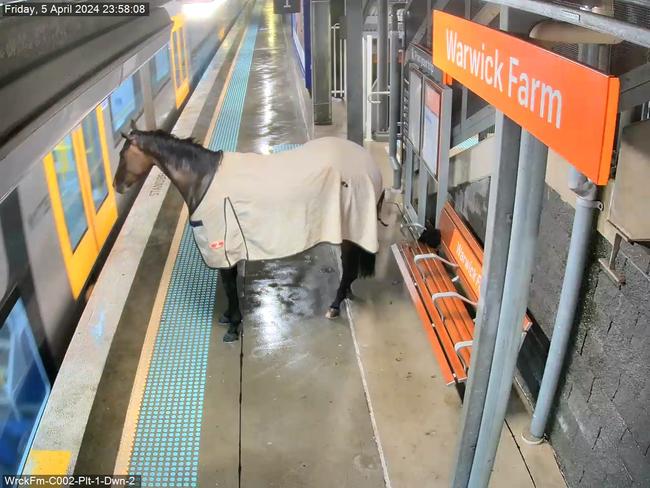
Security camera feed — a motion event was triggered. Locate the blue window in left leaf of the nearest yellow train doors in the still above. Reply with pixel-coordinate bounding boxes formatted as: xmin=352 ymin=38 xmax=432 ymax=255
xmin=52 ymin=135 xmax=88 ymax=250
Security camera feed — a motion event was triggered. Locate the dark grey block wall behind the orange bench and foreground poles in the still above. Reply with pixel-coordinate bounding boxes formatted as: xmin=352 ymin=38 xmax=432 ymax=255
xmin=452 ymin=178 xmax=650 ymax=488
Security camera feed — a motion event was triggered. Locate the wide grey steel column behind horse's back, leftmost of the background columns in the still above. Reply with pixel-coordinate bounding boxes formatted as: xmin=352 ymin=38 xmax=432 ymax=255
xmin=310 ymin=0 xmax=332 ymax=125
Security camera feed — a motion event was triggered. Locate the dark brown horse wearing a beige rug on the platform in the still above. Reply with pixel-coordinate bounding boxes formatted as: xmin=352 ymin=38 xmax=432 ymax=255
xmin=113 ymin=122 xmax=384 ymax=342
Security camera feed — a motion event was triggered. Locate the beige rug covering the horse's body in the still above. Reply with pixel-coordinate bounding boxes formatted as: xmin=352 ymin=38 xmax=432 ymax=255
xmin=190 ymin=137 xmax=382 ymax=268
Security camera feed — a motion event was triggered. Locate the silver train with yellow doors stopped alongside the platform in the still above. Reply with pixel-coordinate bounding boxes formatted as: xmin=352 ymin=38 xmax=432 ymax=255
xmin=0 ymin=0 xmax=250 ymax=473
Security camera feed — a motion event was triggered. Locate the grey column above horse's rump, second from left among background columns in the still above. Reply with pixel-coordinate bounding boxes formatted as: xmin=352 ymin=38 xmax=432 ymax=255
xmin=345 ymin=0 xmax=364 ymax=144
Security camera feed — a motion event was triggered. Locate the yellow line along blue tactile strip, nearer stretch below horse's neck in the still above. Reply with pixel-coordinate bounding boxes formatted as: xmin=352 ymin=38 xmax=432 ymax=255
xmin=114 ymin=205 xmax=187 ymax=475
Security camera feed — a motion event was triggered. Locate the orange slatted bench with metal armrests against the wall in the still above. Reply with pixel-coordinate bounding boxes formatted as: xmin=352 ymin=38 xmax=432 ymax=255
xmin=392 ymin=203 xmax=532 ymax=385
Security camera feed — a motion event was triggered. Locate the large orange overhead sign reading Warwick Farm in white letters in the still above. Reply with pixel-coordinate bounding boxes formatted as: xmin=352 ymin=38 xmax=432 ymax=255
xmin=433 ymin=10 xmax=620 ymax=185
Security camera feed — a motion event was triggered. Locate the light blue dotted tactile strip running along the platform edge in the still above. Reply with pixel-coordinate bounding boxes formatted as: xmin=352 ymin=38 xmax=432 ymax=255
xmin=129 ymin=6 xmax=260 ymax=488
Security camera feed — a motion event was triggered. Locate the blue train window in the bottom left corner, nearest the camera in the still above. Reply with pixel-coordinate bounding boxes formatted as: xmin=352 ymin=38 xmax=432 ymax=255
xmin=0 ymin=296 xmax=50 ymax=473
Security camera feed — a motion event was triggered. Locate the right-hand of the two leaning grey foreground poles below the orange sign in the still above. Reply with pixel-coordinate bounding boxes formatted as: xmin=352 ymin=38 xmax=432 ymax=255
xmin=468 ymin=130 xmax=548 ymax=488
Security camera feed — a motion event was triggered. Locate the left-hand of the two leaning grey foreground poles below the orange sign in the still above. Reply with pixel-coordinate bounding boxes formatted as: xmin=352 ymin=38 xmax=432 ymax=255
xmin=451 ymin=112 xmax=521 ymax=488
